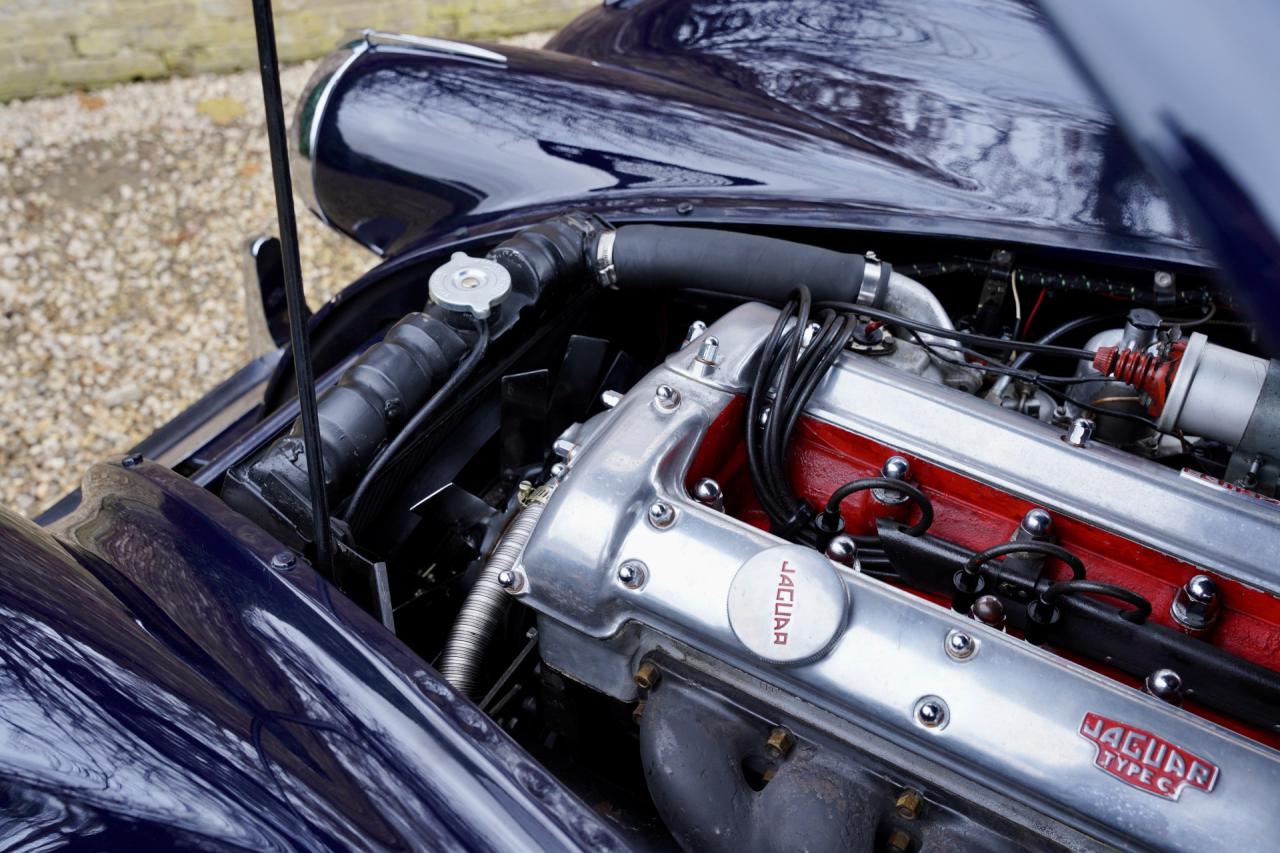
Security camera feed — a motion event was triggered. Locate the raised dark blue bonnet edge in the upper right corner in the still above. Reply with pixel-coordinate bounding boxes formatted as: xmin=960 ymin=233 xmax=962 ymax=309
xmin=1042 ymin=0 xmax=1280 ymax=347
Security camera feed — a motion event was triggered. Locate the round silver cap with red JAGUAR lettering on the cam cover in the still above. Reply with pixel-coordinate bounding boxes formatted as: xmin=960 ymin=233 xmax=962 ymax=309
xmin=728 ymin=546 xmax=849 ymax=663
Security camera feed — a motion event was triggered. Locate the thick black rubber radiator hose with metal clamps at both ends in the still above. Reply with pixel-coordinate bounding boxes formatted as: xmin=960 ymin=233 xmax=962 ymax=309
xmin=596 ymin=225 xmax=890 ymax=305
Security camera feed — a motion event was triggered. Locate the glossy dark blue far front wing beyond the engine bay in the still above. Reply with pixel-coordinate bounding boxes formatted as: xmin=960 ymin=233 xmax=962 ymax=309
xmin=304 ymin=0 xmax=1201 ymax=261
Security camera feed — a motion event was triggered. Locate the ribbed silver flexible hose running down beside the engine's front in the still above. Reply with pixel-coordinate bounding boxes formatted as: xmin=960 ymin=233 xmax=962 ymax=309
xmin=439 ymin=485 xmax=554 ymax=698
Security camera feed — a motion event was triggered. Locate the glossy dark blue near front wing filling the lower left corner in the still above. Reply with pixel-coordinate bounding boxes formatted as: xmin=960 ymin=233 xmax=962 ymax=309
xmin=0 ymin=464 xmax=618 ymax=850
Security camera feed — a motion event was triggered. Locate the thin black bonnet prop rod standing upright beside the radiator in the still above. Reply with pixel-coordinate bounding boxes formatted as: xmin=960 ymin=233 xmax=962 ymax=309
xmin=253 ymin=0 xmax=333 ymax=580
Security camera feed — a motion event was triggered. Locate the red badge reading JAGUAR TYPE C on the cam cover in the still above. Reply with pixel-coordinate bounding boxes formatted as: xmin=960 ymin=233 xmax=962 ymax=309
xmin=1080 ymin=712 xmax=1217 ymax=799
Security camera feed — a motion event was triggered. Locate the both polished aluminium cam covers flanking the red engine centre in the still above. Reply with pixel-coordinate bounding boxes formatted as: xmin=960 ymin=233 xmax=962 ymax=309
xmin=517 ymin=305 xmax=1280 ymax=850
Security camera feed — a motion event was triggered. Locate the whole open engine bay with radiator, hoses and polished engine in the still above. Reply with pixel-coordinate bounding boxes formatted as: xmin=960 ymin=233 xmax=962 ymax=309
xmin=219 ymin=214 xmax=1280 ymax=850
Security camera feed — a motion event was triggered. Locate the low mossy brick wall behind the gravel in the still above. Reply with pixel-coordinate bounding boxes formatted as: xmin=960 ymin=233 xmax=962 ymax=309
xmin=0 ymin=0 xmax=588 ymax=102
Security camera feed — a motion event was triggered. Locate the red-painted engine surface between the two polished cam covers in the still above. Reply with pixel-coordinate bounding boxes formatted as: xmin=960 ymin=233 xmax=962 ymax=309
xmin=687 ymin=397 xmax=1280 ymax=748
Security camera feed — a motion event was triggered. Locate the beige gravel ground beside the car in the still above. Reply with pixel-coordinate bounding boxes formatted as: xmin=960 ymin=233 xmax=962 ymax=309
xmin=0 ymin=33 xmax=545 ymax=515
